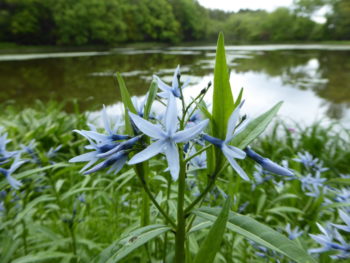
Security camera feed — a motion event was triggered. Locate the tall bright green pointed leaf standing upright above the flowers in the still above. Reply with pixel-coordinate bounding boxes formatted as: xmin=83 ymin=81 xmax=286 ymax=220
xmin=213 ymin=33 xmax=233 ymax=139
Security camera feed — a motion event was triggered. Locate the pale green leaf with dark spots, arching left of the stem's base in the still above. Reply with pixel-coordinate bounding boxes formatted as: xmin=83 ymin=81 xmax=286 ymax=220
xmin=94 ymin=225 xmax=171 ymax=263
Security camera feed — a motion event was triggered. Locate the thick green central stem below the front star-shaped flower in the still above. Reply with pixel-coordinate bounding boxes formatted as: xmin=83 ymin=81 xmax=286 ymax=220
xmin=175 ymin=144 xmax=186 ymax=263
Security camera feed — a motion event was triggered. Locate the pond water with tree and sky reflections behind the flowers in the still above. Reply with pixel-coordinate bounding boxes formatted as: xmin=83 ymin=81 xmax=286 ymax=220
xmin=0 ymin=45 xmax=350 ymax=125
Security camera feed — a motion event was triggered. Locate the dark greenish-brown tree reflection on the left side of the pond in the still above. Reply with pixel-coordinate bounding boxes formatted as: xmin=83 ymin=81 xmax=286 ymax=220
xmin=0 ymin=50 xmax=205 ymax=110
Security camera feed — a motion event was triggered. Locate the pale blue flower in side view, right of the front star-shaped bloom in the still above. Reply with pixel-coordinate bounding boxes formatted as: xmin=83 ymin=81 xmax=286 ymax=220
xmin=203 ymin=102 xmax=249 ymax=181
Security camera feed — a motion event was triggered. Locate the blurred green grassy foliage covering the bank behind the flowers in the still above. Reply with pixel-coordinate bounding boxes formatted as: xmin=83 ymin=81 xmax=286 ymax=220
xmin=0 ymin=103 xmax=350 ymax=263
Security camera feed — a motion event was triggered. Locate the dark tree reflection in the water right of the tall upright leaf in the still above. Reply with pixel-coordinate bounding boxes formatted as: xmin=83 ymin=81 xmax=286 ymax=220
xmin=234 ymin=50 xmax=350 ymax=118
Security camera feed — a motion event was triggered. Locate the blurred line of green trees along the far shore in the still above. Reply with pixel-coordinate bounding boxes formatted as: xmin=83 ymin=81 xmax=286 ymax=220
xmin=0 ymin=0 xmax=350 ymax=46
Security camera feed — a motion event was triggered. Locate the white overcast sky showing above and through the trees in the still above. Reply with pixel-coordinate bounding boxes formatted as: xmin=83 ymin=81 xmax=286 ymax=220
xmin=197 ymin=0 xmax=328 ymax=23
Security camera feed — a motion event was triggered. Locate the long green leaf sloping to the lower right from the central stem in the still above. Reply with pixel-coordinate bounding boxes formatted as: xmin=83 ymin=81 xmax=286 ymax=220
xmin=193 ymin=207 xmax=316 ymax=263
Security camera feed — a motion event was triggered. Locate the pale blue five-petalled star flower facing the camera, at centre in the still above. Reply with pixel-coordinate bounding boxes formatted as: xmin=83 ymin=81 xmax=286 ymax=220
xmin=129 ymin=95 xmax=209 ymax=180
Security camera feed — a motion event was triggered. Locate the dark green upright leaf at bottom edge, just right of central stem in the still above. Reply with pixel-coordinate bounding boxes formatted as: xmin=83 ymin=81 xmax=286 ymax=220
xmin=194 ymin=198 xmax=231 ymax=263
